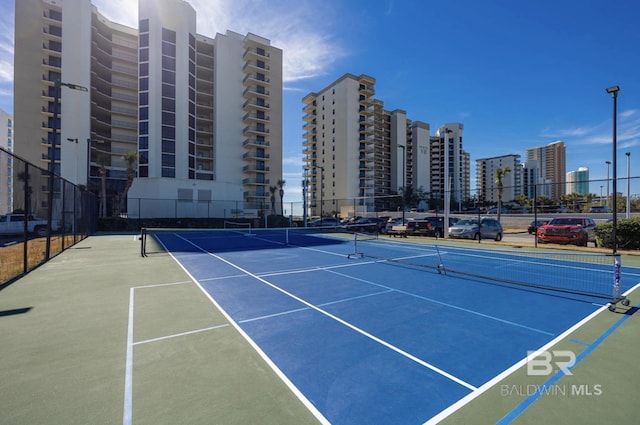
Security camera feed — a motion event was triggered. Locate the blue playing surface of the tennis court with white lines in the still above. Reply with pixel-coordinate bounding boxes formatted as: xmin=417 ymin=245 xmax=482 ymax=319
xmin=150 ymin=232 xmax=637 ymax=424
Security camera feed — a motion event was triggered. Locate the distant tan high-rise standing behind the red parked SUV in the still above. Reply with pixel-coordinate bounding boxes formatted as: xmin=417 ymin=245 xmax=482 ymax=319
xmin=526 ymin=140 xmax=567 ymax=202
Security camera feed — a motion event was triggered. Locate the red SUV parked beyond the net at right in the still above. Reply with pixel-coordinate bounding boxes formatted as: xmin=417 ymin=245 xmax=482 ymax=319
xmin=536 ymin=217 xmax=596 ymax=246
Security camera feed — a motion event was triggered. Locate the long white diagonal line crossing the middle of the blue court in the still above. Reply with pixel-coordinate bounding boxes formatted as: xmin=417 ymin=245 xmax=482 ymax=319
xmin=172 ymin=235 xmax=477 ymax=390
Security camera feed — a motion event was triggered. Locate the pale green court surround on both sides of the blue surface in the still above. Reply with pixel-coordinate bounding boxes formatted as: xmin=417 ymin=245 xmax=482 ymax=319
xmin=0 ymin=235 xmax=640 ymax=424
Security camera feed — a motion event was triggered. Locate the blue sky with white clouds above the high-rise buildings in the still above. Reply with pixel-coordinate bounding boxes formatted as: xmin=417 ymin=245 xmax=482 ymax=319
xmin=0 ymin=0 xmax=640 ymax=202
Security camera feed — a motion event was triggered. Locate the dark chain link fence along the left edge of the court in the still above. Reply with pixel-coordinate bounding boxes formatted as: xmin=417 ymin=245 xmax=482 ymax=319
xmin=0 ymin=148 xmax=97 ymax=288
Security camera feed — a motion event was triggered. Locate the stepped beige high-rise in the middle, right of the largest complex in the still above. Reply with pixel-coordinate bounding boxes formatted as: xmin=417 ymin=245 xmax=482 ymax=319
xmin=302 ymin=74 xmax=469 ymax=217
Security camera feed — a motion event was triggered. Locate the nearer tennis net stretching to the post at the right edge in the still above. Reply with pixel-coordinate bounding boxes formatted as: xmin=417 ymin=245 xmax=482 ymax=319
xmin=357 ymin=235 xmax=629 ymax=305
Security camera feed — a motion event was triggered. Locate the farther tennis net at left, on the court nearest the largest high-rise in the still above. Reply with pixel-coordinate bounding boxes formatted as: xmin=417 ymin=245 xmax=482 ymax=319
xmin=140 ymin=224 xmax=354 ymax=257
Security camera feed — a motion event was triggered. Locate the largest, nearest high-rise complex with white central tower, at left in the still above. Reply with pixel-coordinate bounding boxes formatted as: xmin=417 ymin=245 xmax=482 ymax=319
xmin=14 ymin=0 xmax=282 ymax=217
